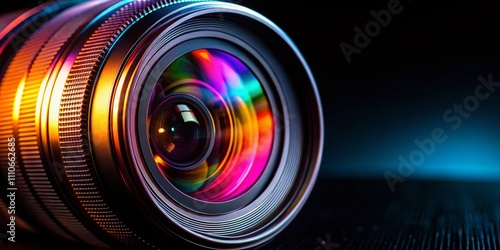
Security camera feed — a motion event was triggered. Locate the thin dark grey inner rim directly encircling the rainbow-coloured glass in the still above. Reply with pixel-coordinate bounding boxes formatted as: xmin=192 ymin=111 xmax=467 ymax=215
xmin=136 ymin=37 xmax=283 ymax=214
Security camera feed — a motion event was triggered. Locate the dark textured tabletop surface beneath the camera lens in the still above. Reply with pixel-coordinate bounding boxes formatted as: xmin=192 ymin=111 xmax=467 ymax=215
xmin=2 ymin=179 xmax=500 ymax=250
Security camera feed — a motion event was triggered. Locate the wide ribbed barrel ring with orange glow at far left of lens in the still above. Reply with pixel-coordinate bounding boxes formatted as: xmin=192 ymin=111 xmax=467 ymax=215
xmin=0 ymin=1 xmax=116 ymax=247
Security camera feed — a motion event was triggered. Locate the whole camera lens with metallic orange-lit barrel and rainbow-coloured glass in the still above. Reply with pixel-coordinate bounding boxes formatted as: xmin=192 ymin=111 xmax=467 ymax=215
xmin=0 ymin=0 xmax=323 ymax=249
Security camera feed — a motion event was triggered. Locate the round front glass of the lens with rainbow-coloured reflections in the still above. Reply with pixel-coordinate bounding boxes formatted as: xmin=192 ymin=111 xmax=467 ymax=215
xmin=148 ymin=49 xmax=274 ymax=202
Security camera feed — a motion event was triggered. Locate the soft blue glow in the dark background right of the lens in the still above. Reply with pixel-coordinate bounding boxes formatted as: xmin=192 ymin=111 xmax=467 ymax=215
xmin=321 ymin=63 xmax=500 ymax=181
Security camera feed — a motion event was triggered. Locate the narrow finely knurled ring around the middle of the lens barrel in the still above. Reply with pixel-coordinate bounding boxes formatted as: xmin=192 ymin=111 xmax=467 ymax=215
xmin=58 ymin=0 xmax=206 ymax=246
